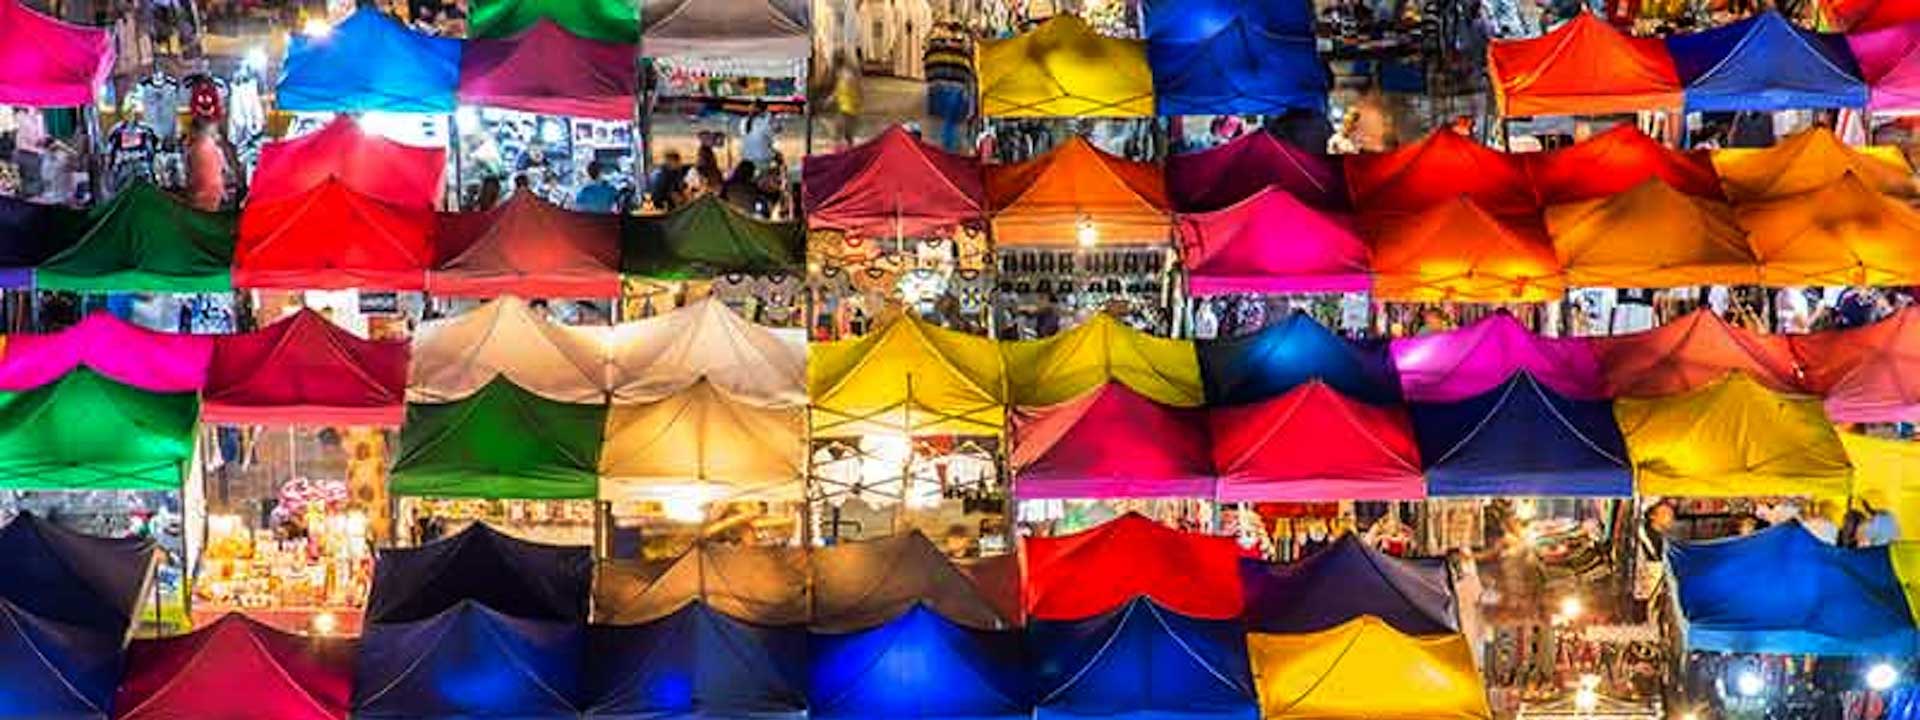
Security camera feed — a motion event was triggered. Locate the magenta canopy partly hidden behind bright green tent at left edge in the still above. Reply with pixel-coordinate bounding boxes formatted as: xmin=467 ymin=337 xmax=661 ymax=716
xmin=0 ymin=311 xmax=213 ymax=392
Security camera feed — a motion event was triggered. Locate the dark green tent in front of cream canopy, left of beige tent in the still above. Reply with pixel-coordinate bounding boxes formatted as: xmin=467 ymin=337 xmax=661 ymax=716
xmin=390 ymin=376 xmax=607 ymax=499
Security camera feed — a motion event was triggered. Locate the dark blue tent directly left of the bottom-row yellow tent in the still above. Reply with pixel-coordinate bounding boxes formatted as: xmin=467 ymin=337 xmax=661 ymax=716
xmin=1027 ymin=597 xmax=1260 ymax=720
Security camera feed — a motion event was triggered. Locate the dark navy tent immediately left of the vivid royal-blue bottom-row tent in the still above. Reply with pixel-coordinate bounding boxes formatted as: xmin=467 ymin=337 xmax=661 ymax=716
xmin=588 ymin=601 xmax=806 ymax=720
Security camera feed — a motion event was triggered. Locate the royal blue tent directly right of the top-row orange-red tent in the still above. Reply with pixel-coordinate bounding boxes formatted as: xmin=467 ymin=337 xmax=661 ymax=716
xmin=1667 ymin=12 xmax=1866 ymax=113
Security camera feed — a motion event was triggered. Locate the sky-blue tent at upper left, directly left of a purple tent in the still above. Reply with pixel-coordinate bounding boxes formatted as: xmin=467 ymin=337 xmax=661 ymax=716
xmin=275 ymin=8 xmax=461 ymax=113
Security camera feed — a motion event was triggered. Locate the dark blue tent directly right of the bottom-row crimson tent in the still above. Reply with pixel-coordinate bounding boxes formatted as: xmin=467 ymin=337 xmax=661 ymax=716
xmin=353 ymin=603 xmax=586 ymax=718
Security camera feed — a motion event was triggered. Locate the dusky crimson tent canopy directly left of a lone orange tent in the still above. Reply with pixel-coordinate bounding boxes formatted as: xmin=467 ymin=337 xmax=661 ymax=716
xmin=801 ymin=125 xmax=987 ymax=238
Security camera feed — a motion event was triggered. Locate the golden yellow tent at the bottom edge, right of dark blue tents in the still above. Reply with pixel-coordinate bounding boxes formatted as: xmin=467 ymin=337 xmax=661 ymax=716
xmin=1246 ymin=614 xmax=1494 ymax=720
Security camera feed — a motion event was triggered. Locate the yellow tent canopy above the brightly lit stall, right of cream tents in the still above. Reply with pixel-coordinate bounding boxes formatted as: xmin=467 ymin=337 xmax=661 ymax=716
xmin=806 ymin=313 xmax=1006 ymax=438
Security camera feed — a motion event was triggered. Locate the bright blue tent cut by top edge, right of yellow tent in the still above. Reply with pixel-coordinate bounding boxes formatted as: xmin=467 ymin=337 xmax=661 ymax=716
xmin=1146 ymin=0 xmax=1332 ymax=115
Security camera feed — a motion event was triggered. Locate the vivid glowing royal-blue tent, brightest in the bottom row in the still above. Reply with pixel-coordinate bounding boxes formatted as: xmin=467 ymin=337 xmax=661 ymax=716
xmin=806 ymin=605 xmax=1033 ymax=720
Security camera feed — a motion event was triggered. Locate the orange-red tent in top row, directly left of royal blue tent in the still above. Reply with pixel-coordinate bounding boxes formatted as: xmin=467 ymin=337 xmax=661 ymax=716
xmin=1486 ymin=12 xmax=1682 ymax=117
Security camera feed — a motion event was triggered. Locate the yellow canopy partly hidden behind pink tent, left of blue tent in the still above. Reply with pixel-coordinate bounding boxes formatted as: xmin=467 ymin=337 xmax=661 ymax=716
xmin=1000 ymin=313 xmax=1206 ymax=407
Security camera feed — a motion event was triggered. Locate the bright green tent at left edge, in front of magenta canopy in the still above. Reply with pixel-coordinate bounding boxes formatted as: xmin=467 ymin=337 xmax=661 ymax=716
xmin=0 ymin=369 xmax=200 ymax=490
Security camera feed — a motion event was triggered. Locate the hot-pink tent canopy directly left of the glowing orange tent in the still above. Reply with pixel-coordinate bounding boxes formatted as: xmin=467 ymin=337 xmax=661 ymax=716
xmin=1175 ymin=186 xmax=1371 ymax=296
